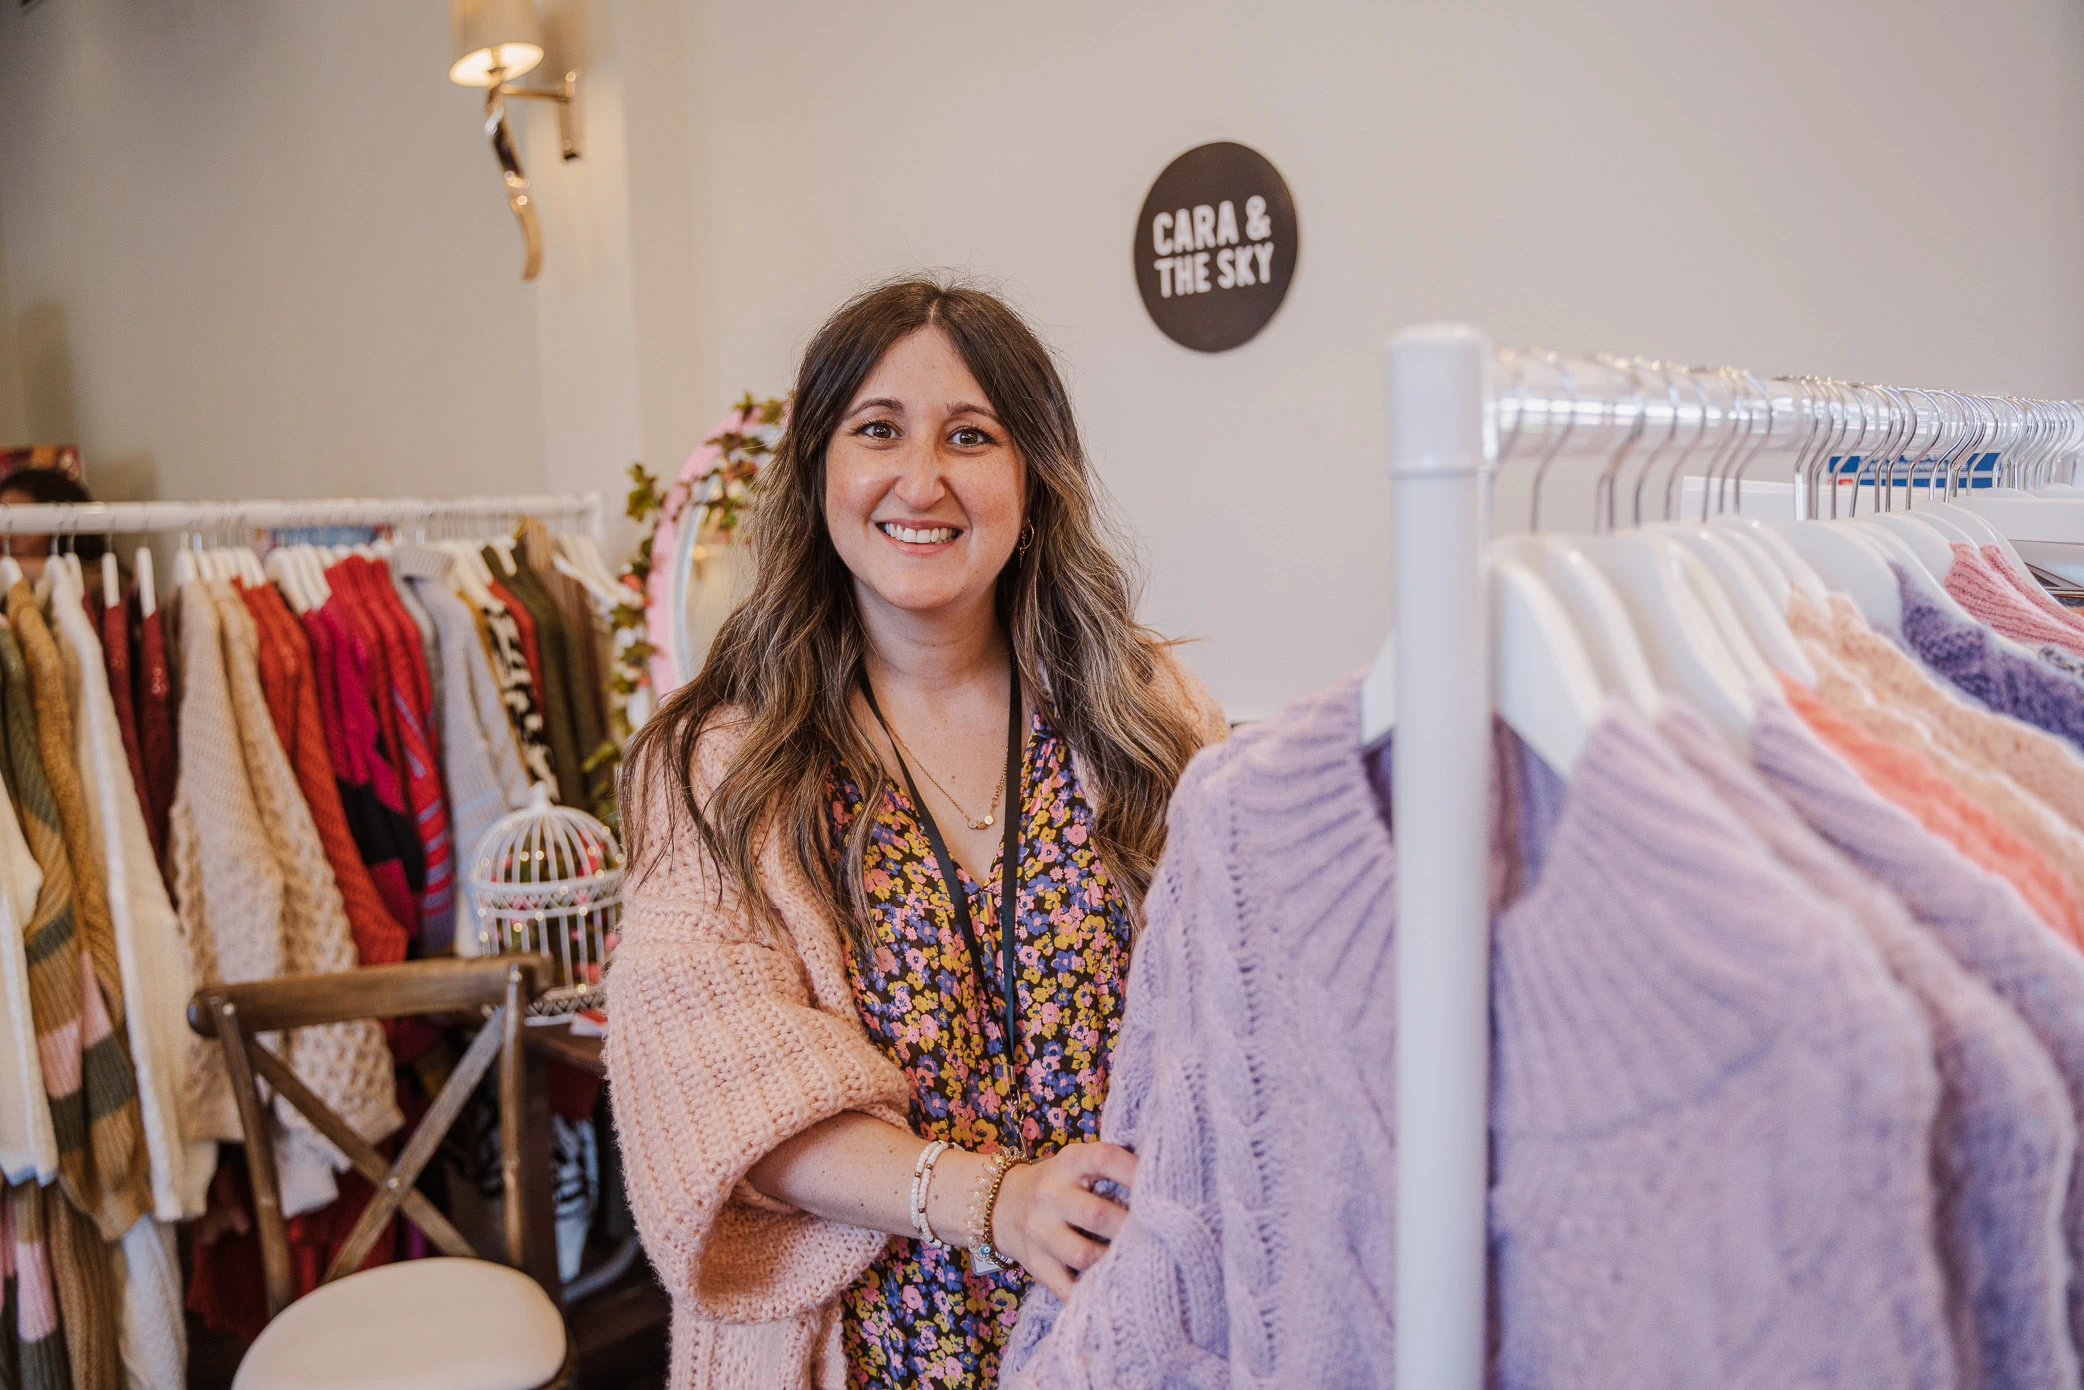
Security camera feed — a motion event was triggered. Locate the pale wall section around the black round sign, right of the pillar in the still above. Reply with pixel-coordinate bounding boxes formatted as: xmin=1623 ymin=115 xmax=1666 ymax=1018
xmin=690 ymin=0 xmax=2084 ymax=715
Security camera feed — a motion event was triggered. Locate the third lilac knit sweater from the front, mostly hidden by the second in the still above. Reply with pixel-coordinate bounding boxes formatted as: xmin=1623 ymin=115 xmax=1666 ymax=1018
xmin=1657 ymin=706 xmax=2078 ymax=1390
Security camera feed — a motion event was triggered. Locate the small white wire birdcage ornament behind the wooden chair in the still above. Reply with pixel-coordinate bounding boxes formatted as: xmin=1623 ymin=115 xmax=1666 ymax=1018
xmin=465 ymin=784 xmax=623 ymax=1015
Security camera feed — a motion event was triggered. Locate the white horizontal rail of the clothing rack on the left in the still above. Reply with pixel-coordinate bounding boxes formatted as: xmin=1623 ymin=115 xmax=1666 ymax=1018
xmin=0 ymin=492 xmax=602 ymax=544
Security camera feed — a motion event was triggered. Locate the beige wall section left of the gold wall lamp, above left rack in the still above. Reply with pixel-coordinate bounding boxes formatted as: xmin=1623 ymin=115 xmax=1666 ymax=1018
xmin=0 ymin=0 xmax=544 ymax=506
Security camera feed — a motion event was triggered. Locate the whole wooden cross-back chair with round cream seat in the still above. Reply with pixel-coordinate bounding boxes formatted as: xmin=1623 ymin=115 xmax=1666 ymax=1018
xmin=188 ymin=957 xmax=577 ymax=1390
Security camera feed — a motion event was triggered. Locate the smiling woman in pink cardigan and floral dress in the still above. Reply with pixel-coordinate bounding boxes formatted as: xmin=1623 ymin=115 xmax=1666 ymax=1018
xmin=609 ymin=279 xmax=1223 ymax=1386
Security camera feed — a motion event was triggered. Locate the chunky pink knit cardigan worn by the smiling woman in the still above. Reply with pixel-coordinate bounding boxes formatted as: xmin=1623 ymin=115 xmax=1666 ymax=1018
xmin=606 ymin=656 xmax=1227 ymax=1390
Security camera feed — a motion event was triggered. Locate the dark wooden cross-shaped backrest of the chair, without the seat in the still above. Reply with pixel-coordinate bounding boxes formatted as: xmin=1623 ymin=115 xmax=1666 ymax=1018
xmin=188 ymin=954 xmax=552 ymax=1317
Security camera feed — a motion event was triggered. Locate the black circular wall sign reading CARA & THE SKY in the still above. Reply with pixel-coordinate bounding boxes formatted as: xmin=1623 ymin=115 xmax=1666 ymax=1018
xmin=1136 ymin=140 xmax=1296 ymax=352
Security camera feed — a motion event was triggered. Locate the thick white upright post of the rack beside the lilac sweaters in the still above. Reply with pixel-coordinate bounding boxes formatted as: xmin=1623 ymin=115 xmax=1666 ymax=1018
xmin=1388 ymin=325 xmax=1498 ymax=1390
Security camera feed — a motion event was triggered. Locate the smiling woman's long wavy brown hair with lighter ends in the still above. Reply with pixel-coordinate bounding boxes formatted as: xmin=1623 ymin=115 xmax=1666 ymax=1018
xmin=623 ymin=277 xmax=1200 ymax=942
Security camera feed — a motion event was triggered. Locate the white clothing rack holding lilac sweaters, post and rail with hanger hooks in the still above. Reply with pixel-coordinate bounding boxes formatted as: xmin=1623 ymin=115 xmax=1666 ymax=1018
xmin=1386 ymin=325 xmax=2084 ymax=1390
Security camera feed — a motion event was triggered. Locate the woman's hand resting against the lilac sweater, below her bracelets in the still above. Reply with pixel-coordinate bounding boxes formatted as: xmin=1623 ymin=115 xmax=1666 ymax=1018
xmin=992 ymin=1142 xmax=1136 ymax=1298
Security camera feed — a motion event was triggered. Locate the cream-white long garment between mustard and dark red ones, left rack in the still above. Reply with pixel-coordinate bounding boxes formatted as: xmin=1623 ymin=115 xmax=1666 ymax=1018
xmin=50 ymin=569 xmax=217 ymax=1225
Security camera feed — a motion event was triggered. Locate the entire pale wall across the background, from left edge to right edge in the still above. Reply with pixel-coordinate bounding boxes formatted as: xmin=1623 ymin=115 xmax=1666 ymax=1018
xmin=0 ymin=0 xmax=2084 ymax=715
